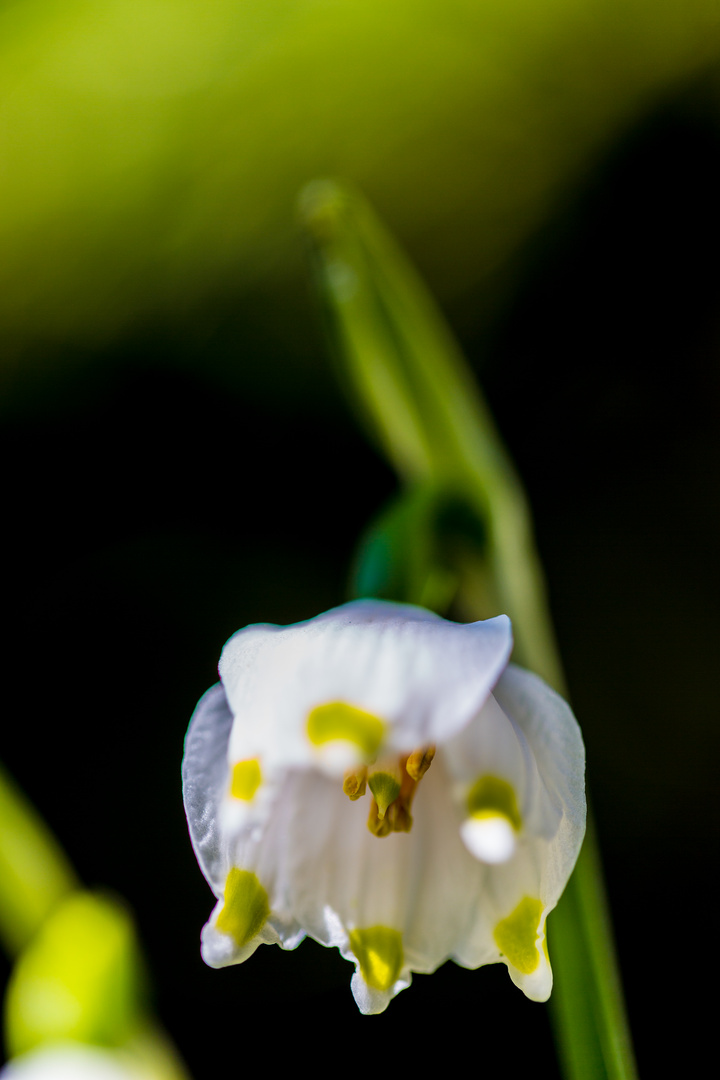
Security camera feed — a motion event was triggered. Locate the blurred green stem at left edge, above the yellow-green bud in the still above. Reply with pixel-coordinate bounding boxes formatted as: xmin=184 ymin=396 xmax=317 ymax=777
xmin=0 ymin=765 xmax=78 ymax=956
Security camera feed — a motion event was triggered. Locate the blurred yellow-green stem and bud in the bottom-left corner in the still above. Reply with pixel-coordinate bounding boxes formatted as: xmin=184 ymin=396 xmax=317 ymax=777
xmin=0 ymin=767 xmax=188 ymax=1080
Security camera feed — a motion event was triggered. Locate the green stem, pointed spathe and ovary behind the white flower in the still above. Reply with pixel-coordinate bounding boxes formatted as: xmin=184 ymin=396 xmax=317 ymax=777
xmin=301 ymin=181 xmax=637 ymax=1080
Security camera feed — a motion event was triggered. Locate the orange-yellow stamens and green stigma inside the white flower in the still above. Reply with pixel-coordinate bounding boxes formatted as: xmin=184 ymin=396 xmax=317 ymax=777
xmin=342 ymin=746 xmax=435 ymax=836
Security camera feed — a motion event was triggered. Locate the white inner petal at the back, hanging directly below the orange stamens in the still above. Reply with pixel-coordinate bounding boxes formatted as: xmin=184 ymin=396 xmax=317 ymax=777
xmin=276 ymin=756 xmax=490 ymax=1012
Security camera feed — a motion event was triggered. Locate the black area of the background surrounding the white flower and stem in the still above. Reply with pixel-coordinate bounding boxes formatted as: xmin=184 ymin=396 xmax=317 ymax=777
xmin=0 ymin=82 xmax=720 ymax=1078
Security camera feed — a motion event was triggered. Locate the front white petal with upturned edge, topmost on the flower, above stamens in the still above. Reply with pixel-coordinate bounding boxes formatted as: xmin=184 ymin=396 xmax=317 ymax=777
xmin=220 ymin=600 xmax=512 ymax=771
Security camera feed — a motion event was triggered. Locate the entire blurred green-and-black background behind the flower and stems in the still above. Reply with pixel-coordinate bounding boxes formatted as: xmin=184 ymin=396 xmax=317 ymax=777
xmin=0 ymin=0 xmax=720 ymax=1080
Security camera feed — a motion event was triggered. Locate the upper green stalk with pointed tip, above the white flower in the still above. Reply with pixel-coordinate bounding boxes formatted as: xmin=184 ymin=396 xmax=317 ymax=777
xmin=300 ymin=181 xmax=560 ymax=689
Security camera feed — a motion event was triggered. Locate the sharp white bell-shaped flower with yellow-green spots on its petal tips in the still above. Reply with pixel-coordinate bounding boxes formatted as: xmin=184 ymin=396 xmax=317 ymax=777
xmin=182 ymin=600 xmax=585 ymax=1013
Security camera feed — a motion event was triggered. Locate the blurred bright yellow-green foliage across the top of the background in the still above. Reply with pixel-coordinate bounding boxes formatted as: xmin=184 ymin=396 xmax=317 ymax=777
xmin=0 ymin=0 xmax=720 ymax=406
